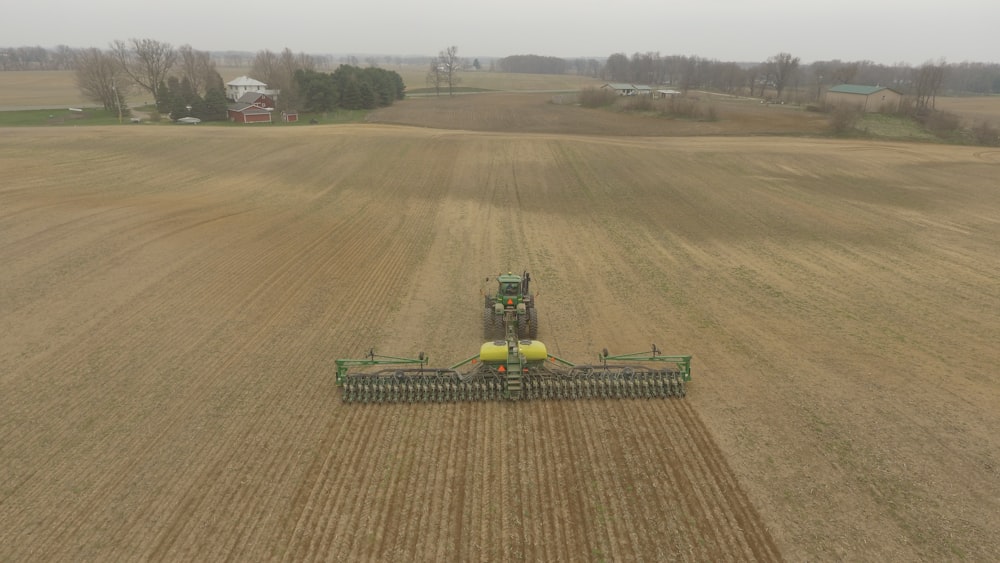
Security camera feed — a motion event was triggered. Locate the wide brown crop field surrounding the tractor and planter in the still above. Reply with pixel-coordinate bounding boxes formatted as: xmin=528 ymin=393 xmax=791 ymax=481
xmin=0 ymin=91 xmax=1000 ymax=561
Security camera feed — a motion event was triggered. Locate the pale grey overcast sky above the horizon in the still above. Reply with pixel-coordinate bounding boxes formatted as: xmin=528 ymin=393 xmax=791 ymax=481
xmin=0 ymin=0 xmax=1000 ymax=66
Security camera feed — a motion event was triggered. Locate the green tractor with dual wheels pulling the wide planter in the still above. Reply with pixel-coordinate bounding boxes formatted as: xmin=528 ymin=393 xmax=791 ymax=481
xmin=483 ymin=272 xmax=538 ymax=340
